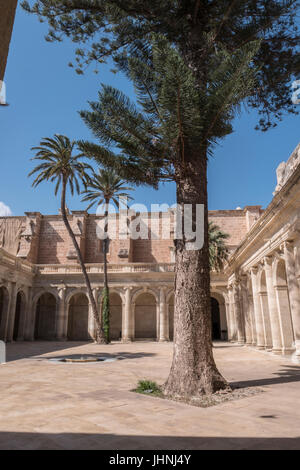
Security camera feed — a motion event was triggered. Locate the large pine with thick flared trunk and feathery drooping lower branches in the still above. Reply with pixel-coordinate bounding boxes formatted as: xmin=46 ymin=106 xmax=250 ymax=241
xmin=80 ymin=37 xmax=260 ymax=396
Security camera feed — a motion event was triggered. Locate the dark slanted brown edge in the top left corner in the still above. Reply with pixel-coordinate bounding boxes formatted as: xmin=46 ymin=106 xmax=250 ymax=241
xmin=0 ymin=0 xmax=18 ymax=82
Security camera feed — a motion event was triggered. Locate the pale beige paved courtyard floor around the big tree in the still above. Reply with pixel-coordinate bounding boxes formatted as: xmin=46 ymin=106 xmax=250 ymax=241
xmin=0 ymin=342 xmax=300 ymax=450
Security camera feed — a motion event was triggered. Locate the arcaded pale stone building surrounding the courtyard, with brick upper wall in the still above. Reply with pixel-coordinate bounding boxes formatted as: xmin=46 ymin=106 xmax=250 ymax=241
xmin=0 ymin=145 xmax=300 ymax=361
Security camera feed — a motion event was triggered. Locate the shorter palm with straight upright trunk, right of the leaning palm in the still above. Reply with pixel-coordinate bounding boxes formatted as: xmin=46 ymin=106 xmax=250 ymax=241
xmin=82 ymin=169 xmax=133 ymax=341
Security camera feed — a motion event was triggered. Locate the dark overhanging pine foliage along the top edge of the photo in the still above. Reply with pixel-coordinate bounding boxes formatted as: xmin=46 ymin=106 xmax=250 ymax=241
xmin=22 ymin=0 xmax=300 ymax=130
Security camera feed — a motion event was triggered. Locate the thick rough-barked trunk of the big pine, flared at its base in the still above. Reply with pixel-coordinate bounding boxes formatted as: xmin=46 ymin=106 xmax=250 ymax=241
xmin=164 ymin=152 xmax=229 ymax=398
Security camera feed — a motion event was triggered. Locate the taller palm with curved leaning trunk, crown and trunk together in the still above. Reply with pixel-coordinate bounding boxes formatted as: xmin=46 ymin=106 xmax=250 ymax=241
xmin=28 ymin=134 xmax=106 ymax=344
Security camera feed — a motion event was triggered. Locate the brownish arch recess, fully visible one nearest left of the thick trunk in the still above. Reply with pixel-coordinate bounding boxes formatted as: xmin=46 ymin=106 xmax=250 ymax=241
xmin=133 ymin=289 xmax=158 ymax=339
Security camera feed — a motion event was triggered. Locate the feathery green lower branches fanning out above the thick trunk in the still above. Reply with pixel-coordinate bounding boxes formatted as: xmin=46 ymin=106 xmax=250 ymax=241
xmin=79 ymin=35 xmax=260 ymax=188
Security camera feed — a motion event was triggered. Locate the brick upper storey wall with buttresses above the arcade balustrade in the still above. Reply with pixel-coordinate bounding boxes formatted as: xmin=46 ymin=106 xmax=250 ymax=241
xmin=0 ymin=206 xmax=262 ymax=264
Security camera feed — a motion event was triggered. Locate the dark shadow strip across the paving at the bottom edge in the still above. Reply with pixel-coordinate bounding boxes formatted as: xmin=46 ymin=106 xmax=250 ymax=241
xmin=0 ymin=432 xmax=300 ymax=452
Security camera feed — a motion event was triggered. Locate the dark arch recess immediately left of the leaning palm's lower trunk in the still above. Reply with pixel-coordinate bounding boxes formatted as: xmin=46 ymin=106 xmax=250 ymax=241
xmin=67 ymin=291 xmax=91 ymax=341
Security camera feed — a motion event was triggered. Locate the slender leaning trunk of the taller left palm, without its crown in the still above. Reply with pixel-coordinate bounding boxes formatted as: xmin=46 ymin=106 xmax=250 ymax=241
xmin=61 ymin=181 xmax=107 ymax=344
